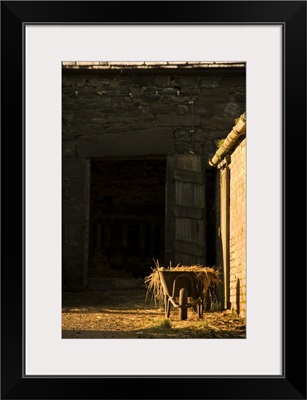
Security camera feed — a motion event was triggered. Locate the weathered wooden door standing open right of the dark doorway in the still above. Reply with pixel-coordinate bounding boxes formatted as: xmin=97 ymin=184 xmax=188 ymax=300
xmin=165 ymin=154 xmax=206 ymax=266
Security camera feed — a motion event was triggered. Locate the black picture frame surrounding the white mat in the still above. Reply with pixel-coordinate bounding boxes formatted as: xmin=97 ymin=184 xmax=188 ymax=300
xmin=1 ymin=1 xmax=306 ymax=399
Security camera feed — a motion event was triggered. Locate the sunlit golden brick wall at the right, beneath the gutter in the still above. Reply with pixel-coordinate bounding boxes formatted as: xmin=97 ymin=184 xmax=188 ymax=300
xmin=229 ymin=138 xmax=246 ymax=316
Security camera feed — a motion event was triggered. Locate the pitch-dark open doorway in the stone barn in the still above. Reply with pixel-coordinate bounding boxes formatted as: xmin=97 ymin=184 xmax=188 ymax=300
xmin=88 ymin=158 xmax=166 ymax=278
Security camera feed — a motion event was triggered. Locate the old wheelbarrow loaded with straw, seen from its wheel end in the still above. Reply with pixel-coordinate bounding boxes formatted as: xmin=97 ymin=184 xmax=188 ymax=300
xmin=159 ymin=271 xmax=204 ymax=320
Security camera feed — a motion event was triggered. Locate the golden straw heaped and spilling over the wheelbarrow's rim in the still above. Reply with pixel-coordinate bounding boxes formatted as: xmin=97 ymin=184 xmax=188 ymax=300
xmin=144 ymin=260 xmax=221 ymax=306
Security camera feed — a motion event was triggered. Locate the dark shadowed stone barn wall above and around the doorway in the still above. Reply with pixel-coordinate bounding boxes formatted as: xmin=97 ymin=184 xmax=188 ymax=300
xmin=62 ymin=62 xmax=245 ymax=295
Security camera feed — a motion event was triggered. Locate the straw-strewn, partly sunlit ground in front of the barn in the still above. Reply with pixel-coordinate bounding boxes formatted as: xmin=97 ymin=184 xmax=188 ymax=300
xmin=62 ymin=278 xmax=246 ymax=339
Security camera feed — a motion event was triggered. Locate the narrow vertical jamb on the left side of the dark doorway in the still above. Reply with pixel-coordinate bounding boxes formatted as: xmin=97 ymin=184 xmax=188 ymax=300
xmin=83 ymin=158 xmax=91 ymax=288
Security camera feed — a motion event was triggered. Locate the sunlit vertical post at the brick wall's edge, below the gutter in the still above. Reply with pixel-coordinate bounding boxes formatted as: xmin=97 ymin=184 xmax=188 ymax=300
xmin=220 ymin=167 xmax=230 ymax=309
